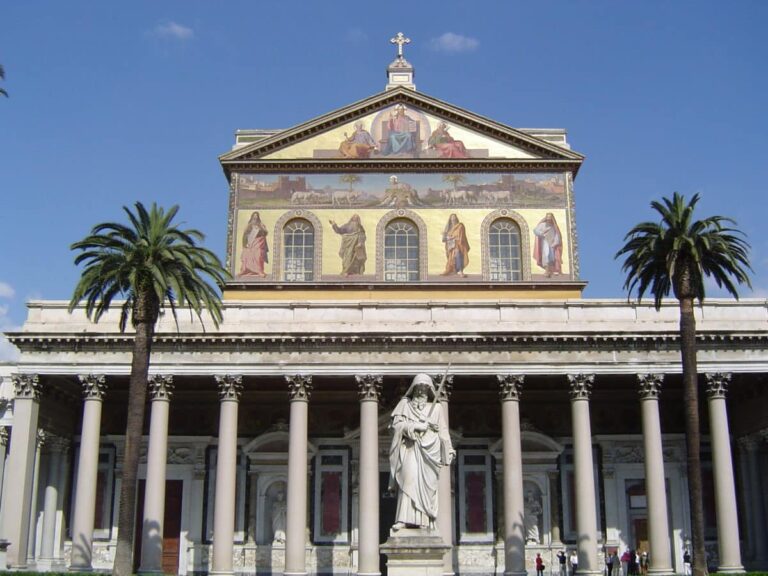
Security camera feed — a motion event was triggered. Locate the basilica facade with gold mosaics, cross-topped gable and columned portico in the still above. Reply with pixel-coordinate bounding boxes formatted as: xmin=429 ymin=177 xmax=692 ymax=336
xmin=0 ymin=37 xmax=768 ymax=575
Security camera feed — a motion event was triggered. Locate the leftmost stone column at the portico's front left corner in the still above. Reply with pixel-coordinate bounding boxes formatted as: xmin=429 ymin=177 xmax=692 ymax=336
xmin=3 ymin=374 xmax=40 ymax=569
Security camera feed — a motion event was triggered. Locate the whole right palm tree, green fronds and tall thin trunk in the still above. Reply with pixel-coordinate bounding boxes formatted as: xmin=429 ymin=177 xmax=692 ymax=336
xmin=615 ymin=192 xmax=751 ymax=576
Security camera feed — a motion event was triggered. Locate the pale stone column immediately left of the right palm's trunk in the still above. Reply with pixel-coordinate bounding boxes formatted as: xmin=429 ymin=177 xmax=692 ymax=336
xmin=637 ymin=374 xmax=674 ymax=575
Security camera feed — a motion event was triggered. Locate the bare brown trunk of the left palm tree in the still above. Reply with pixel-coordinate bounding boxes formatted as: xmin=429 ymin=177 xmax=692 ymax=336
xmin=112 ymin=316 xmax=157 ymax=576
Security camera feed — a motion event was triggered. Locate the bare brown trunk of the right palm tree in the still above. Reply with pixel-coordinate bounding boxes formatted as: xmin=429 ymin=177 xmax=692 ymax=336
xmin=680 ymin=297 xmax=707 ymax=576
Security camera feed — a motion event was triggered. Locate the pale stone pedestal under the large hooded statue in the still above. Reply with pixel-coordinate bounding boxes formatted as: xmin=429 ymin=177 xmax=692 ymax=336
xmin=379 ymin=528 xmax=451 ymax=576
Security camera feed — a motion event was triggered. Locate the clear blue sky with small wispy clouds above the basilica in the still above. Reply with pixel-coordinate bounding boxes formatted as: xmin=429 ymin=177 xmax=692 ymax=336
xmin=0 ymin=0 xmax=768 ymax=354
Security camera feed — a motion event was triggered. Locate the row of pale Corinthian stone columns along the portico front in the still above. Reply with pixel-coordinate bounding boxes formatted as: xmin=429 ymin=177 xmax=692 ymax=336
xmin=0 ymin=374 xmax=743 ymax=576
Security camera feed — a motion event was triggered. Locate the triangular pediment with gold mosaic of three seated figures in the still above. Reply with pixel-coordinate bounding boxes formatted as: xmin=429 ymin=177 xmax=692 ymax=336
xmin=220 ymin=88 xmax=583 ymax=171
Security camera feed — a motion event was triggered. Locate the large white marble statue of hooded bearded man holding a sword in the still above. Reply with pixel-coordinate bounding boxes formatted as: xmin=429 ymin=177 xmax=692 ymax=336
xmin=389 ymin=374 xmax=456 ymax=531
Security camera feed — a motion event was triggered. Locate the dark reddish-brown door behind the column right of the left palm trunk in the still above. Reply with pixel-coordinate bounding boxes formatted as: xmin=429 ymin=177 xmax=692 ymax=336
xmin=133 ymin=480 xmax=184 ymax=574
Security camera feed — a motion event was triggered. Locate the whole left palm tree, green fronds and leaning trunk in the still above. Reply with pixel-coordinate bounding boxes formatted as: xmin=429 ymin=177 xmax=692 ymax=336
xmin=69 ymin=202 xmax=227 ymax=576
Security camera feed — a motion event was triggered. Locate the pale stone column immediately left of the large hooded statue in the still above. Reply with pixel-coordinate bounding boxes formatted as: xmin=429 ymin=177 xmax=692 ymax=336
xmin=355 ymin=374 xmax=382 ymax=576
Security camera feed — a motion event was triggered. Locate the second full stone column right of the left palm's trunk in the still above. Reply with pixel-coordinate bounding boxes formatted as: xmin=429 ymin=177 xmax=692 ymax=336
xmin=210 ymin=374 xmax=243 ymax=576
